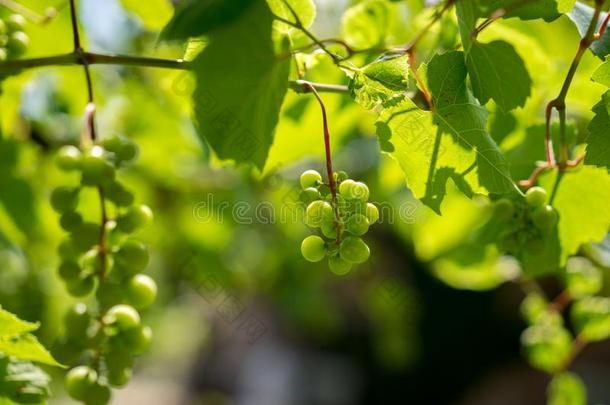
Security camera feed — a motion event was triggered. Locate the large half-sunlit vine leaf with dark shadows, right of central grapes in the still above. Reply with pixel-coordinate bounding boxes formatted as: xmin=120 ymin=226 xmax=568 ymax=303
xmin=376 ymin=52 xmax=512 ymax=213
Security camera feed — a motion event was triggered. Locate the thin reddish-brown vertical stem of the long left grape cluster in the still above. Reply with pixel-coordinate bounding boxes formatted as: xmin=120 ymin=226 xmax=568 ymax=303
xmin=70 ymin=0 xmax=108 ymax=280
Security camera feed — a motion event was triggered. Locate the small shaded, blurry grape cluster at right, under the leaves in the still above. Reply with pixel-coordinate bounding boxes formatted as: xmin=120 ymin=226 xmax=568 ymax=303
xmin=494 ymin=187 xmax=558 ymax=255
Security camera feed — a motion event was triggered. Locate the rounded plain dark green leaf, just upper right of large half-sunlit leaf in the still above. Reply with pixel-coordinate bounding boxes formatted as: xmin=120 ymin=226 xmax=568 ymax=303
xmin=466 ymin=41 xmax=532 ymax=112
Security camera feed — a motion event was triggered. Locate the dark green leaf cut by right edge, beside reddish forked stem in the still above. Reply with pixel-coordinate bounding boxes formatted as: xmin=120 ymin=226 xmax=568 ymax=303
xmin=585 ymin=92 xmax=610 ymax=168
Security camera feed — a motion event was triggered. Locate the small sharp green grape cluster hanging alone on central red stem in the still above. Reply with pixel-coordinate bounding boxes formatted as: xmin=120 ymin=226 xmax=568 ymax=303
xmin=300 ymin=170 xmax=379 ymax=275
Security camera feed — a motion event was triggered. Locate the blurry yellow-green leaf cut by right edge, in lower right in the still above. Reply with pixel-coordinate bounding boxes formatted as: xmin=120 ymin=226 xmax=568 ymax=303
xmin=570 ymin=297 xmax=610 ymax=342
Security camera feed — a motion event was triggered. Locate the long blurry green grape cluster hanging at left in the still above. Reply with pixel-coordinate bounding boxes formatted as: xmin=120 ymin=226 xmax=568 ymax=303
xmin=51 ymin=136 xmax=157 ymax=405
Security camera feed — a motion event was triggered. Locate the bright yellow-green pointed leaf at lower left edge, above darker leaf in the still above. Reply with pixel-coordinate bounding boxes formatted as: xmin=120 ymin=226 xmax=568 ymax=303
xmin=0 ymin=308 xmax=61 ymax=367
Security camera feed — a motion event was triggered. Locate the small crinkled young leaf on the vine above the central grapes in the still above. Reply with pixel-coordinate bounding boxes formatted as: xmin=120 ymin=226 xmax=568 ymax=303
xmin=349 ymin=55 xmax=409 ymax=109
